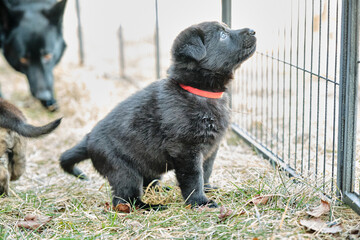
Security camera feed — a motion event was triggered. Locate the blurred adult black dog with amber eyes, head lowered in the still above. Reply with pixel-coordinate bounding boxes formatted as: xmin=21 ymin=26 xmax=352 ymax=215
xmin=0 ymin=0 xmax=67 ymax=111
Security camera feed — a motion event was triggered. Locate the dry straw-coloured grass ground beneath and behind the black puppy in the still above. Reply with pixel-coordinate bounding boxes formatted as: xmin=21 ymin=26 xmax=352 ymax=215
xmin=0 ymin=61 xmax=360 ymax=239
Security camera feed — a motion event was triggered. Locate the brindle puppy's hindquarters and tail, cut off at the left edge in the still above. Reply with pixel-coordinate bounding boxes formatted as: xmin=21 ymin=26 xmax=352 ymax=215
xmin=0 ymin=98 xmax=61 ymax=196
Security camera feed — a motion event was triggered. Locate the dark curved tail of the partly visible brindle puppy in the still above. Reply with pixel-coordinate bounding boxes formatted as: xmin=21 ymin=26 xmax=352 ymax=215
xmin=0 ymin=100 xmax=61 ymax=138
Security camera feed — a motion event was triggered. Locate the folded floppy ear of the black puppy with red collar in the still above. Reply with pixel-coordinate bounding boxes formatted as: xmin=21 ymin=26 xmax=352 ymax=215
xmin=173 ymin=28 xmax=206 ymax=61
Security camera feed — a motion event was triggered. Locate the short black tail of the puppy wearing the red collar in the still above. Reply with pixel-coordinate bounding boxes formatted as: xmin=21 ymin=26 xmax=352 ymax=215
xmin=60 ymin=135 xmax=89 ymax=180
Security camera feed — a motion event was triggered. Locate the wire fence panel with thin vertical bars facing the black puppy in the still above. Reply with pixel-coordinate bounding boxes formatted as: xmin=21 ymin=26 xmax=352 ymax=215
xmin=232 ymin=0 xmax=360 ymax=214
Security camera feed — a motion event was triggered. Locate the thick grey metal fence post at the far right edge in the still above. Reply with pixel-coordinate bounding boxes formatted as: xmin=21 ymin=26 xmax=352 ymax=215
xmin=337 ymin=0 xmax=360 ymax=213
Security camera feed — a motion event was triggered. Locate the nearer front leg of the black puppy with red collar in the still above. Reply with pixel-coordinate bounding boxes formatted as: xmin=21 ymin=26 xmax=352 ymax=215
xmin=174 ymin=156 xmax=217 ymax=207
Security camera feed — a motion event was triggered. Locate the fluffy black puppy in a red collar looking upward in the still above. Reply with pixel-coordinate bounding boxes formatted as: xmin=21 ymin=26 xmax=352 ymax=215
xmin=60 ymin=22 xmax=256 ymax=207
